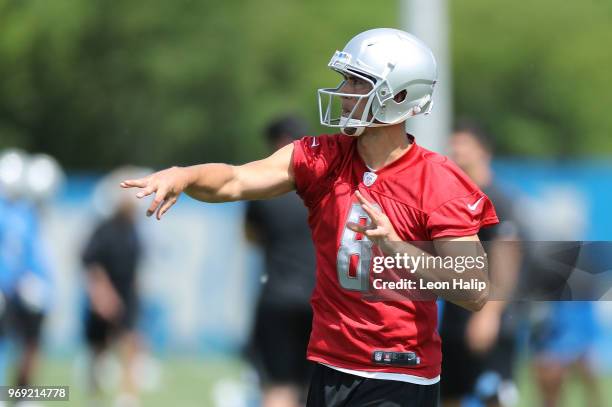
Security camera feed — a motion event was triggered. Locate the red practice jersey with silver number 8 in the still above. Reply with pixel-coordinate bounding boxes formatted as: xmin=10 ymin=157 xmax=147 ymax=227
xmin=293 ymin=134 xmax=498 ymax=379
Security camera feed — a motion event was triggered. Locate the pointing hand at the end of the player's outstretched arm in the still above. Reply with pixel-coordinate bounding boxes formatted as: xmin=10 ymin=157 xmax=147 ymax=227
xmin=120 ymin=167 xmax=188 ymax=220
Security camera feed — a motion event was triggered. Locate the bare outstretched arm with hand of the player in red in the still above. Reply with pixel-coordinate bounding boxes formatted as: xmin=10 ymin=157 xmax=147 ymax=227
xmin=121 ymin=144 xmax=295 ymax=220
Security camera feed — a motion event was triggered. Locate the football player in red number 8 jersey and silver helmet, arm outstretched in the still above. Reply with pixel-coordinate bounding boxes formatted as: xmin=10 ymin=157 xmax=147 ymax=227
xmin=121 ymin=28 xmax=498 ymax=407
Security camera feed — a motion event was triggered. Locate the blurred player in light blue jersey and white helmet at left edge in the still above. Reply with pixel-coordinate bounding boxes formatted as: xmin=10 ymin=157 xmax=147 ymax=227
xmin=0 ymin=150 xmax=63 ymax=398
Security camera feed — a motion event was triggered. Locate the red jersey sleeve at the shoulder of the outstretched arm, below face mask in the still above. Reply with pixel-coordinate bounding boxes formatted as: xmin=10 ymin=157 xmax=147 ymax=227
xmin=293 ymin=135 xmax=346 ymax=207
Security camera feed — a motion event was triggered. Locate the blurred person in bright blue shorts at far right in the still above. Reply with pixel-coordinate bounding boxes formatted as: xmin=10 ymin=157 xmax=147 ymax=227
xmin=519 ymin=162 xmax=611 ymax=407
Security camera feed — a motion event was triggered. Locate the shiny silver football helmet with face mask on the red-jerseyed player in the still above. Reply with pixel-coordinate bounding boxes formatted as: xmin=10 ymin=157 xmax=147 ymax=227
xmin=318 ymin=28 xmax=437 ymax=136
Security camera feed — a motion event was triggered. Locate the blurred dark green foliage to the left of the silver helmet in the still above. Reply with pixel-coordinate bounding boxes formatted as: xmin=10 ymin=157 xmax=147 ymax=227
xmin=0 ymin=0 xmax=394 ymax=170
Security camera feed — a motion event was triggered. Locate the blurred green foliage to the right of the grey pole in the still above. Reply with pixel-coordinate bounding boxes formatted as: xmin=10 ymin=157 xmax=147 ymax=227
xmin=450 ymin=0 xmax=612 ymax=157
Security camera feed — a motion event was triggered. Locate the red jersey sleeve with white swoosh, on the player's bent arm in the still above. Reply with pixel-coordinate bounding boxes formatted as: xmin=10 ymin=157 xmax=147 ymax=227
xmin=427 ymin=191 xmax=499 ymax=240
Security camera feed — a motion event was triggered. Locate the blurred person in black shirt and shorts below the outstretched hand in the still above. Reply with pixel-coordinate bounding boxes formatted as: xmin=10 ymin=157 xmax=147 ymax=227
xmin=82 ymin=168 xmax=147 ymax=406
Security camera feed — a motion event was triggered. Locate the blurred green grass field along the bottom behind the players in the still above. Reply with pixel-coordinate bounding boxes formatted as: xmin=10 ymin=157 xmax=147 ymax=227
xmin=16 ymin=359 xmax=612 ymax=407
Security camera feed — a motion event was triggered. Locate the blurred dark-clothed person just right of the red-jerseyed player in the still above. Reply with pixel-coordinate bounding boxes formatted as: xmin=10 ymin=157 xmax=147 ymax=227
xmin=440 ymin=121 xmax=520 ymax=407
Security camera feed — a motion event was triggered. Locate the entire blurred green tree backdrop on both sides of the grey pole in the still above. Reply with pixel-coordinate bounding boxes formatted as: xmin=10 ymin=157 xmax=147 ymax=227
xmin=0 ymin=0 xmax=612 ymax=170
